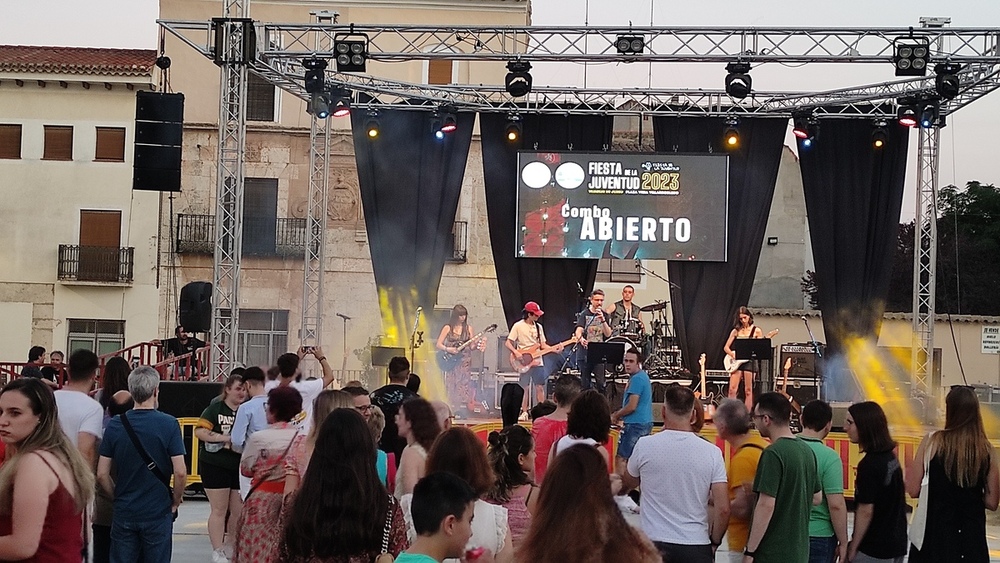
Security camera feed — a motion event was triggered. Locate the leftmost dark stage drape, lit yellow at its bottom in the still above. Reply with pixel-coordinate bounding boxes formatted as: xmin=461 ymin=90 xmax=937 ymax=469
xmin=351 ymin=109 xmax=476 ymax=346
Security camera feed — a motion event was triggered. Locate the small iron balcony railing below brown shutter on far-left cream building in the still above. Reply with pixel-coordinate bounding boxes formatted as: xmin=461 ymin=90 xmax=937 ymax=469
xmin=58 ymin=244 xmax=135 ymax=285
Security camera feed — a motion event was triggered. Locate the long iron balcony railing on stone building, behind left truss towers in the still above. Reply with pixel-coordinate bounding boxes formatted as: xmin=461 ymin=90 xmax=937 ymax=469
xmin=174 ymin=214 xmax=306 ymax=256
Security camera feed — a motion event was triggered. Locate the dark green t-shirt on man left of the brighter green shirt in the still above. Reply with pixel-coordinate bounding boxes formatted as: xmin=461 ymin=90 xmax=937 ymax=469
xmin=750 ymin=438 xmax=820 ymax=563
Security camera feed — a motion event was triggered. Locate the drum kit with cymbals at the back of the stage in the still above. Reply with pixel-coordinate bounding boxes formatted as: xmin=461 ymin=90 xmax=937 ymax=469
xmin=607 ymin=301 xmax=683 ymax=379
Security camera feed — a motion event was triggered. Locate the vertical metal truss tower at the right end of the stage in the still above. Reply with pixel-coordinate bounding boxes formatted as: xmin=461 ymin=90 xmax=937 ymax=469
xmin=910 ymin=127 xmax=941 ymax=396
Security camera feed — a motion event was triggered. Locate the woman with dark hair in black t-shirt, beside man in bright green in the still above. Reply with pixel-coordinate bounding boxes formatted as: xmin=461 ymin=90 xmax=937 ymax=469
xmin=844 ymin=401 xmax=907 ymax=563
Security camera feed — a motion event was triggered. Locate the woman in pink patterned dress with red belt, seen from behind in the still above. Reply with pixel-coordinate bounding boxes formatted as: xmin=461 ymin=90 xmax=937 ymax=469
xmin=232 ymin=385 xmax=302 ymax=563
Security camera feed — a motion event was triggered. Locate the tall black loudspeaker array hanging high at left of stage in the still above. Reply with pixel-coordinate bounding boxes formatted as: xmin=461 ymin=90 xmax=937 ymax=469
xmin=132 ymin=91 xmax=186 ymax=192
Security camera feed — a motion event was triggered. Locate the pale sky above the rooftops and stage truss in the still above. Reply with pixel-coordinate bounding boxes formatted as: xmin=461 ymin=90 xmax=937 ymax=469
xmin=0 ymin=0 xmax=1000 ymax=220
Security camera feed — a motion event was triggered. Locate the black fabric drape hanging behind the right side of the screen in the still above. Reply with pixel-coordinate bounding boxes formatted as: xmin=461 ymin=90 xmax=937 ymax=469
xmin=653 ymin=117 xmax=788 ymax=371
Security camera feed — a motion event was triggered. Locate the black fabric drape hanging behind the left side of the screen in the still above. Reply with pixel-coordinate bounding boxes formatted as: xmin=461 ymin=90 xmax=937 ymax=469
xmin=479 ymin=113 xmax=612 ymax=343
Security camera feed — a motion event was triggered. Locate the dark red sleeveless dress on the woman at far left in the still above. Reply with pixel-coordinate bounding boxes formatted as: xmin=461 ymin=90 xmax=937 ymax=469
xmin=0 ymin=456 xmax=83 ymax=563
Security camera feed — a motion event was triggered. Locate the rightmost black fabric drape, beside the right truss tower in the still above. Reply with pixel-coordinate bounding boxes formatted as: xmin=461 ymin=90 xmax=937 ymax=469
xmin=799 ymin=119 xmax=909 ymax=391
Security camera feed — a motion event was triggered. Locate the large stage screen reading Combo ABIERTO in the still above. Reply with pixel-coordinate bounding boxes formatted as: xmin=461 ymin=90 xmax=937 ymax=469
xmin=515 ymin=151 xmax=729 ymax=262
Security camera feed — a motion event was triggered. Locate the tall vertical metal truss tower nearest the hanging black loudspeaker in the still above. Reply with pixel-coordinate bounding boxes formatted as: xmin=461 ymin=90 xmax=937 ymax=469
xmin=209 ymin=13 xmax=253 ymax=380
